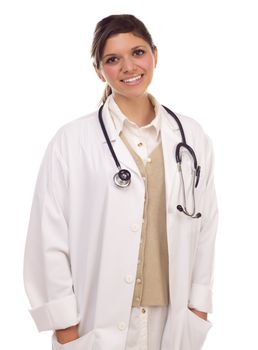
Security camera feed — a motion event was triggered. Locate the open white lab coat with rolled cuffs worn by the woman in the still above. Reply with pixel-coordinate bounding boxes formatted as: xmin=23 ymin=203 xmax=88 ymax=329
xmin=24 ymin=98 xmax=217 ymax=350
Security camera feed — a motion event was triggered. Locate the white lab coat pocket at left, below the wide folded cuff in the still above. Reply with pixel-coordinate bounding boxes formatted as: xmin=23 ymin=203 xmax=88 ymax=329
xmin=52 ymin=331 xmax=95 ymax=350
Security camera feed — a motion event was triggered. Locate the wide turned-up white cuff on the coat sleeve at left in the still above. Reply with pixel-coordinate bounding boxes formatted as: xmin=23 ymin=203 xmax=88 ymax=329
xmin=29 ymin=295 xmax=80 ymax=332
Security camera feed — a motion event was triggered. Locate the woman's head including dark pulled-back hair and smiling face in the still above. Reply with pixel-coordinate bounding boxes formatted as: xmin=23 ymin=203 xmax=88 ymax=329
xmin=92 ymin=15 xmax=157 ymax=121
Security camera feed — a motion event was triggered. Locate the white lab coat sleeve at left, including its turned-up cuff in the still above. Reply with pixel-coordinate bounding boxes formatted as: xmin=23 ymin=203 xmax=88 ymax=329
xmin=24 ymin=135 xmax=79 ymax=331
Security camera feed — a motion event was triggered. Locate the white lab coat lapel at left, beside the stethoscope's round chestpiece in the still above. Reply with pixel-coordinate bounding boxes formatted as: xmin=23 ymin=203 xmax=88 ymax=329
xmin=102 ymin=103 xmax=141 ymax=176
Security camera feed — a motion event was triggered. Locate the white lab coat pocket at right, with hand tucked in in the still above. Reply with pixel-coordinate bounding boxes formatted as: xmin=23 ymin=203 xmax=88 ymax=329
xmin=181 ymin=309 xmax=212 ymax=350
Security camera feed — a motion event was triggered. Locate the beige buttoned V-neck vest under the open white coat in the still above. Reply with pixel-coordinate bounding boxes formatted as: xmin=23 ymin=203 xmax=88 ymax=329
xmin=120 ymin=133 xmax=169 ymax=306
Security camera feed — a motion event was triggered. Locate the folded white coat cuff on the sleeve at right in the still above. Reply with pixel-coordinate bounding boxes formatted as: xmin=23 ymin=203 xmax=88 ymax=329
xmin=188 ymin=283 xmax=213 ymax=313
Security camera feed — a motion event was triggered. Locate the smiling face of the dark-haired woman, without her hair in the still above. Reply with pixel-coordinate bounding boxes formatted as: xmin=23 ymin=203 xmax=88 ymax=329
xmin=96 ymin=33 xmax=157 ymax=98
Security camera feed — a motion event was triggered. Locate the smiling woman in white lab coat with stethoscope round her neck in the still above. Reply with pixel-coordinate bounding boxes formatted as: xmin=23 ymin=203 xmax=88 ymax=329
xmin=24 ymin=15 xmax=217 ymax=350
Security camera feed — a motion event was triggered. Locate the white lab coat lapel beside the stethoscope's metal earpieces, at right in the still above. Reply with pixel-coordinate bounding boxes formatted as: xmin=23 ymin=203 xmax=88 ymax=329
xmin=161 ymin=111 xmax=181 ymax=213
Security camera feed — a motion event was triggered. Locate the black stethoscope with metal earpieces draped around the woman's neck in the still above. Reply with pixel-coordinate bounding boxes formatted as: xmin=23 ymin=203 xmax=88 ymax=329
xmin=98 ymin=105 xmax=201 ymax=219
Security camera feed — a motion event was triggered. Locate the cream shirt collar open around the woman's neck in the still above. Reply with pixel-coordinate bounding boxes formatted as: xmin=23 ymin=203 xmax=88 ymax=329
xmin=107 ymin=94 xmax=161 ymax=138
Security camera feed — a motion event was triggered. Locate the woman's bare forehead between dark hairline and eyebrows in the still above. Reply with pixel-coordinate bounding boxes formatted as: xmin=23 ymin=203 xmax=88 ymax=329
xmin=103 ymin=33 xmax=149 ymax=55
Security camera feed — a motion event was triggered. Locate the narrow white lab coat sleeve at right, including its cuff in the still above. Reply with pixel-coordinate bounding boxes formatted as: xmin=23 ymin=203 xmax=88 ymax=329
xmin=188 ymin=137 xmax=218 ymax=313
